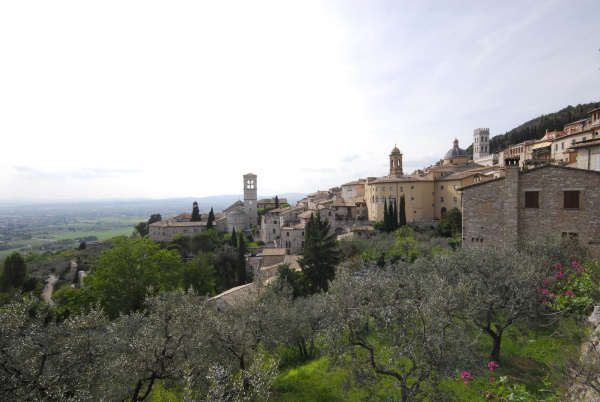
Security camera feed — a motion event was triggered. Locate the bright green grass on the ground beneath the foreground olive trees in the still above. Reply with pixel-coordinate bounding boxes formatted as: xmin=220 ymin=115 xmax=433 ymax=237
xmin=273 ymin=318 xmax=586 ymax=401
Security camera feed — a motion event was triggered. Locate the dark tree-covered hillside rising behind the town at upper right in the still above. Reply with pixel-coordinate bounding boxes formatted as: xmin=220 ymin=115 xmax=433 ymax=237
xmin=467 ymin=102 xmax=600 ymax=157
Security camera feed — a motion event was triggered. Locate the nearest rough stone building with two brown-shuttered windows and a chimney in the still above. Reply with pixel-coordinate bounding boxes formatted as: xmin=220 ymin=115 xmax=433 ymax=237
xmin=461 ymin=159 xmax=600 ymax=255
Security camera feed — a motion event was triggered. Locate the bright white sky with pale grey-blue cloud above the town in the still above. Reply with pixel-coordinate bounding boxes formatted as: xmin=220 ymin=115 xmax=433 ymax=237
xmin=0 ymin=0 xmax=600 ymax=200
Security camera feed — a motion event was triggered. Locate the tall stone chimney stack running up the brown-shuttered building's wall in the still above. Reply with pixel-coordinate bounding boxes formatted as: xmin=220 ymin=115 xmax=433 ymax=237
xmin=503 ymin=158 xmax=519 ymax=247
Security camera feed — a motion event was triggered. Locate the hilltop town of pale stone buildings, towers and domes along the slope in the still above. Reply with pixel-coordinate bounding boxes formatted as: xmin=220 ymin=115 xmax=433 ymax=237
xmin=149 ymin=108 xmax=600 ymax=270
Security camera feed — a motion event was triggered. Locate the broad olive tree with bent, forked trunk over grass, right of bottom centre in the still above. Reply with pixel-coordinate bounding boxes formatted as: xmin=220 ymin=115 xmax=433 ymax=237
xmin=325 ymin=264 xmax=468 ymax=401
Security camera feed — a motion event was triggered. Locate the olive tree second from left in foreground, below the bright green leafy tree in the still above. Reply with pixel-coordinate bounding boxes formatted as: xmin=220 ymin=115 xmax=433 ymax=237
xmin=106 ymin=290 xmax=210 ymax=401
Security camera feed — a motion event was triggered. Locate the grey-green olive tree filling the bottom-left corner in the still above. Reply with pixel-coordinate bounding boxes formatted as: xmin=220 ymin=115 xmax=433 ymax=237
xmin=0 ymin=299 xmax=110 ymax=401
